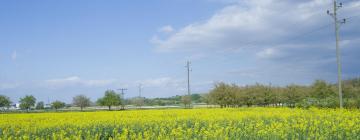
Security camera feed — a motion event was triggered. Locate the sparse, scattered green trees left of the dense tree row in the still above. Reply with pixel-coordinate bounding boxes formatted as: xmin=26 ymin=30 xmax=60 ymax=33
xmin=0 ymin=90 xmax=203 ymax=111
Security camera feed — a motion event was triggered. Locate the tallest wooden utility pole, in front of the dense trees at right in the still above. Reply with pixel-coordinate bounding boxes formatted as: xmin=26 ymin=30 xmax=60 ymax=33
xmin=327 ymin=0 xmax=346 ymax=109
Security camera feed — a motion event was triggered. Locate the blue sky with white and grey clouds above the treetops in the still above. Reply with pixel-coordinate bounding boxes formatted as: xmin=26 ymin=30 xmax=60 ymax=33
xmin=0 ymin=0 xmax=360 ymax=102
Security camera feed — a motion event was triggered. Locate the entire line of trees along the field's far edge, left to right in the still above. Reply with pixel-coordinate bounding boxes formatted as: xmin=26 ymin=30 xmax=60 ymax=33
xmin=0 ymin=78 xmax=360 ymax=111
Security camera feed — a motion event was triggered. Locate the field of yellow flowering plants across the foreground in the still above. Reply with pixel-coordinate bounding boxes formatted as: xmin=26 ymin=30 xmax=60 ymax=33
xmin=0 ymin=108 xmax=360 ymax=140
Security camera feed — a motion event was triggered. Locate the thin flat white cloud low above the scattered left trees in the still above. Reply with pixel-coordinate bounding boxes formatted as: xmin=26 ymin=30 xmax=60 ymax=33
xmin=45 ymin=76 xmax=115 ymax=87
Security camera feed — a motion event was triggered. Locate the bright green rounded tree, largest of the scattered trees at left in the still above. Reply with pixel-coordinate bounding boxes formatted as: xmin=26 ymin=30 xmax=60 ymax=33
xmin=97 ymin=90 xmax=121 ymax=110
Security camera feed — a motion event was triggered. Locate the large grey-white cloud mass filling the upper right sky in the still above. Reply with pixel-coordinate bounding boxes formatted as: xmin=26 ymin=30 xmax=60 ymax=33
xmin=152 ymin=0 xmax=360 ymax=82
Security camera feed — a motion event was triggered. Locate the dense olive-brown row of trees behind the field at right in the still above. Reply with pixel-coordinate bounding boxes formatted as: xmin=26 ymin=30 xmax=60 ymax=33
xmin=204 ymin=78 xmax=360 ymax=108
